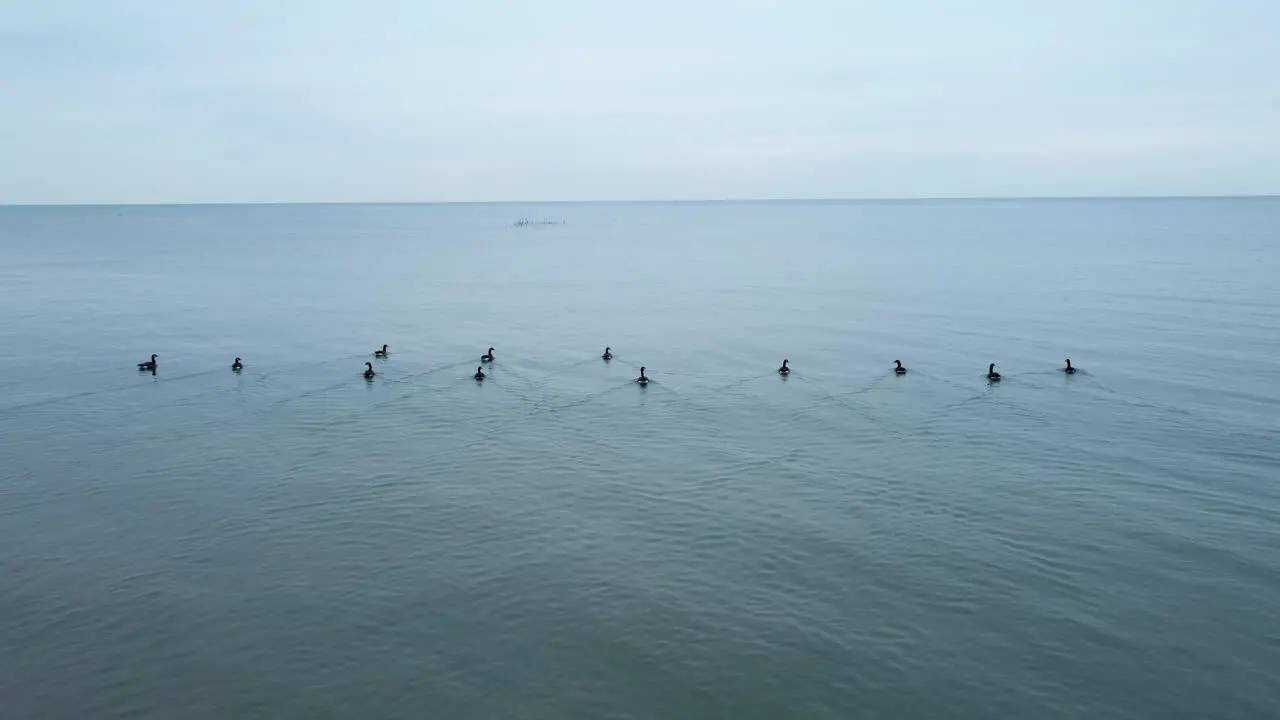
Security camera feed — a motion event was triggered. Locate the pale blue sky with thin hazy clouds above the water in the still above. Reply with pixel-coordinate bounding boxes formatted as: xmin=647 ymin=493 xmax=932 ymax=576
xmin=0 ymin=0 xmax=1280 ymax=202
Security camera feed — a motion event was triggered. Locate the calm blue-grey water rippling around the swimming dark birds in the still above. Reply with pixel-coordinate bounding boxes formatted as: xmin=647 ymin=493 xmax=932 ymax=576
xmin=0 ymin=199 xmax=1280 ymax=719
